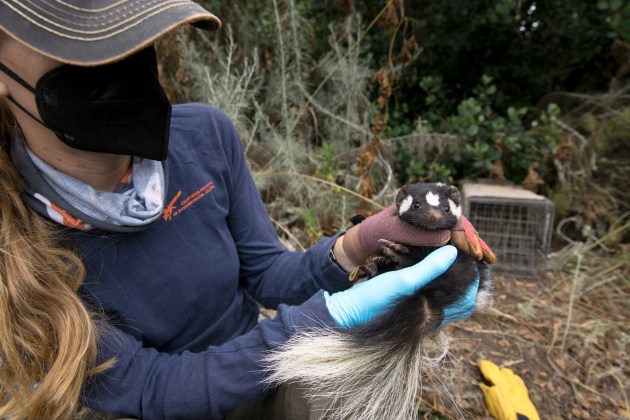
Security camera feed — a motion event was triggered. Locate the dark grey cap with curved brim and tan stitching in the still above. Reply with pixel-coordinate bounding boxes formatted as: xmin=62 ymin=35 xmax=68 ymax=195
xmin=0 ymin=0 xmax=221 ymax=66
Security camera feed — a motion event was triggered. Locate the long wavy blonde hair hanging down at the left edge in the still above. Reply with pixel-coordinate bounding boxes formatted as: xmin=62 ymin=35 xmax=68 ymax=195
xmin=0 ymin=103 xmax=107 ymax=419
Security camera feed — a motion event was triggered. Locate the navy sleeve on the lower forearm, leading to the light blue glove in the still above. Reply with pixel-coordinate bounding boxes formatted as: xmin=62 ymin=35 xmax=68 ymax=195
xmin=83 ymin=292 xmax=335 ymax=420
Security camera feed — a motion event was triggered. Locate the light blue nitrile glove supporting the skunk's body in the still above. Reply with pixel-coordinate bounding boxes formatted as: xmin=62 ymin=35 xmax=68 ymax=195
xmin=324 ymin=245 xmax=460 ymax=328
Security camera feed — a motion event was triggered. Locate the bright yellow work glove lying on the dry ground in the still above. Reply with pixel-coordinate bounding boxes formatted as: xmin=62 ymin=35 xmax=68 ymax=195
xmin=477 ymin=360 xmax=540 ymax=420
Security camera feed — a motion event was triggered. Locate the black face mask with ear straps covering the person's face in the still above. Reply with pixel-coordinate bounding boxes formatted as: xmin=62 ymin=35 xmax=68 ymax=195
xmin=0 ymin=47 xmax=171 ymax=160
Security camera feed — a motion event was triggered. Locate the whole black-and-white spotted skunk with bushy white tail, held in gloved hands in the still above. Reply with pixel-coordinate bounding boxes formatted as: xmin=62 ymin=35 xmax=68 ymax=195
xmin=265 ymin=183 xmax=492 ymax=420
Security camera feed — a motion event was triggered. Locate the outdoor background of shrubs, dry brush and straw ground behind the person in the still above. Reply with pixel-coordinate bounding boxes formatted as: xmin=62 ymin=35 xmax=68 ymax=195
xmin=158 ymin=0 xmax=630 ymax=418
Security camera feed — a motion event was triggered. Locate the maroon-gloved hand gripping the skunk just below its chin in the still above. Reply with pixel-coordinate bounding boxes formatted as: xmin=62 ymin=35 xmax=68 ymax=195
xmin=335 ymin=204 xmax=451 ymax=266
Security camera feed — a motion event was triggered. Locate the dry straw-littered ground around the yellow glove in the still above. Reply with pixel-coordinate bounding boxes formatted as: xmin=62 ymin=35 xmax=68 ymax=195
xmin=420 ymin=245 xmax=630 ymax=419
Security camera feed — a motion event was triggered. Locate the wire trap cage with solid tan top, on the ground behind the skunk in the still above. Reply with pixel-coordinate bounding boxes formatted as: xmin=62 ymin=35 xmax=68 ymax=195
xmin=461 ymin=183 xmax=554 ymax=278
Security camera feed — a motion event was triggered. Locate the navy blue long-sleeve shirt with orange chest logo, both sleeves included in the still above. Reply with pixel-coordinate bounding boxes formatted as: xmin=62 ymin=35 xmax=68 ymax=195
xmin=75 ymin=104 xmax=349 ymax=419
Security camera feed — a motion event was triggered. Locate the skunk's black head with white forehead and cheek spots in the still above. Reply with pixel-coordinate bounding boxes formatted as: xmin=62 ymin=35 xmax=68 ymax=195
xmin=396 ymin=182 xmax=462 ymax=230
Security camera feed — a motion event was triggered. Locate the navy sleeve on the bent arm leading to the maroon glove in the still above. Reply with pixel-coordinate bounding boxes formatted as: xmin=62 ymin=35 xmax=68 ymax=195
xmin=209 ymin=106 xmax=351 ymax=308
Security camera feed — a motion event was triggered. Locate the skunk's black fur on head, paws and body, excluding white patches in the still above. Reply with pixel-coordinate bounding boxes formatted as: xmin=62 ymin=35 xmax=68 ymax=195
xmin=347 ymin=183 xmax=492 ymax=356
